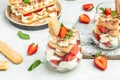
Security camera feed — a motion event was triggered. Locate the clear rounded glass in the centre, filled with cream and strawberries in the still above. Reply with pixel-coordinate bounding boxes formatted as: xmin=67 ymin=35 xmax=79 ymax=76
xmin=45 ymin=22 xmax=82 ymax=72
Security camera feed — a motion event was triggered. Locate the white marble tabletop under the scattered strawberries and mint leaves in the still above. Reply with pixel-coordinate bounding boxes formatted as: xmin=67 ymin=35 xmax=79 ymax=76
xmin=0 ymin=0 xmax=120 ymax=80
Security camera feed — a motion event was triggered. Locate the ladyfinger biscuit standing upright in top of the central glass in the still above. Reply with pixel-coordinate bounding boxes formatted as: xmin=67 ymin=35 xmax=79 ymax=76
xmin=48 ymin=18 xmax=60 ymax=36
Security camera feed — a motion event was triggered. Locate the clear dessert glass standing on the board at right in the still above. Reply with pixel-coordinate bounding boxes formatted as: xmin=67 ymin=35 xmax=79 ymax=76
xmin=92 ymin=2 xmax=120 ymax=50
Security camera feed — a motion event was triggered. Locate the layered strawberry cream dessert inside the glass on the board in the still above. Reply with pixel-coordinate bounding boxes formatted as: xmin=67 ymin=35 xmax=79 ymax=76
xmin=93 ymin=8 xmax=120 ymax=49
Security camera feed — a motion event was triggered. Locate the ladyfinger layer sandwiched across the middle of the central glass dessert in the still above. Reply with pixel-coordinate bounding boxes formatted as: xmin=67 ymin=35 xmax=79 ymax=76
xmin=48 ymin=42 xmax=74 ymax=53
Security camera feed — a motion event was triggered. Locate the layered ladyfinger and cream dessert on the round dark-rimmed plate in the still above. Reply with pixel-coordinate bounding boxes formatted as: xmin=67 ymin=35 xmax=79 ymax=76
xmin=9 ymin=0 xmax=59 ymax=25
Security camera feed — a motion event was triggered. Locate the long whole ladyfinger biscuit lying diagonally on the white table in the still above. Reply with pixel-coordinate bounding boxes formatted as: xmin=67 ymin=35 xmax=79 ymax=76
xmin=0 ymin=40 xmax=23 ymax=64
